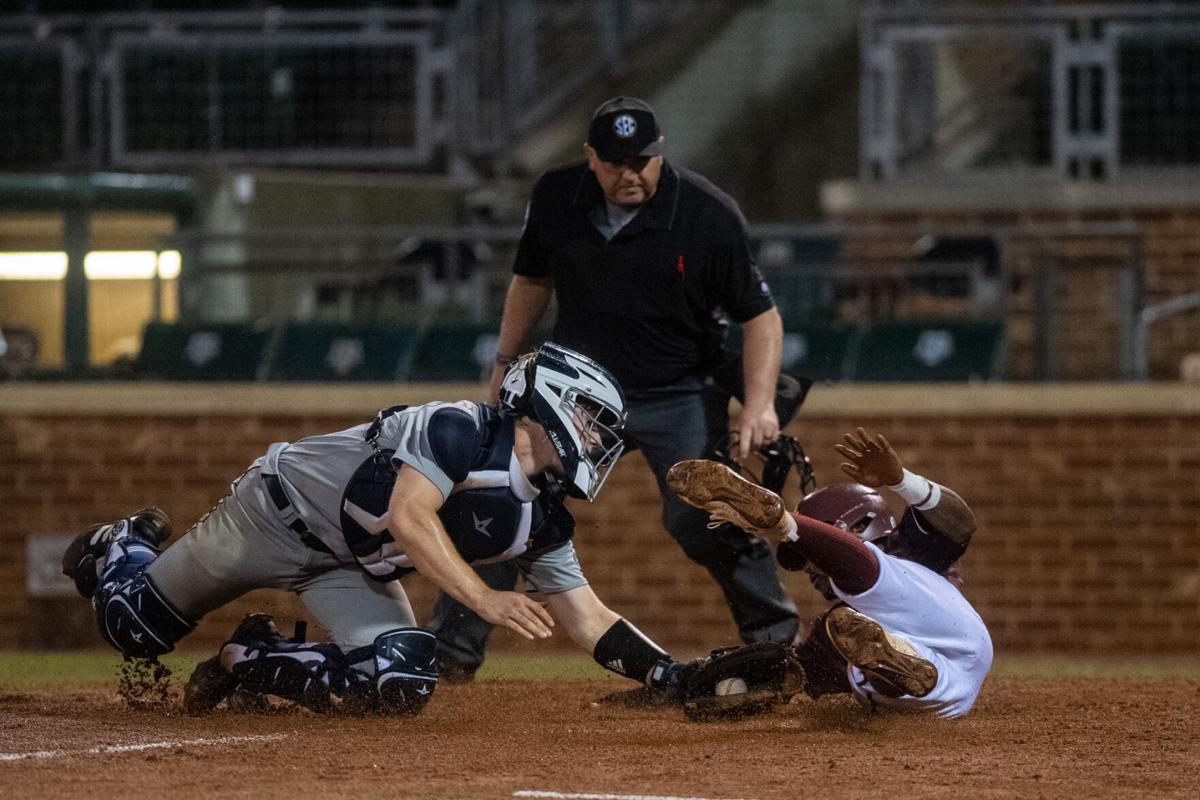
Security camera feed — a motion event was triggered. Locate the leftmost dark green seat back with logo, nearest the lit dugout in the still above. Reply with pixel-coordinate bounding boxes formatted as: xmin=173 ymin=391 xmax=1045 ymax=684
xmin=138 ymin=323 xmax=271 ymax=380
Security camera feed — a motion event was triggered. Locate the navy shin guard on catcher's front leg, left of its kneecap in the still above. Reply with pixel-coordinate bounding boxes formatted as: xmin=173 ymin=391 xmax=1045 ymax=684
xmin=220 ymin=614 xmax=346 ymax=711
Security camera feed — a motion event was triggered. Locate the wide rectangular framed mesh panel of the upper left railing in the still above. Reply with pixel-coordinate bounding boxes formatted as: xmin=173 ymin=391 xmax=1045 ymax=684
xmin=109 ymin=31 xmax=437 ymax=169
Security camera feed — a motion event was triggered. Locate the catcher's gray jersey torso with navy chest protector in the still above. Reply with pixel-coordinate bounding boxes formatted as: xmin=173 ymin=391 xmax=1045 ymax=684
xmin=254 ymin=401 xmax=587 ymax=594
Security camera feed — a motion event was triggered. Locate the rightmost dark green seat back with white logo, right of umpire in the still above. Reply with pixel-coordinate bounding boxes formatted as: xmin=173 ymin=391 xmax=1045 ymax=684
xmin=848 ymin=319 xmax=1004 ymax=381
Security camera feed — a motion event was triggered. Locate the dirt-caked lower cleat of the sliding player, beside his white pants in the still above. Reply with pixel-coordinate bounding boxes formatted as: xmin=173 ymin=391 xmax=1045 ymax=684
xmin=826 ymin=606 xmax=937 ymax=697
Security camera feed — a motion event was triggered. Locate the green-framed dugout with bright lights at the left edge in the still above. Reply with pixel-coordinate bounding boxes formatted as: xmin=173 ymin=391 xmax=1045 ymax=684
xmin=0 ymin=173 xmax=197 ymax=374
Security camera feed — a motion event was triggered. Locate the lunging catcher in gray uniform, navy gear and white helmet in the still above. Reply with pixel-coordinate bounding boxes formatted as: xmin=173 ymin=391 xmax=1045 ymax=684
xmin=62 ymin=344 xmax=683 ymax=714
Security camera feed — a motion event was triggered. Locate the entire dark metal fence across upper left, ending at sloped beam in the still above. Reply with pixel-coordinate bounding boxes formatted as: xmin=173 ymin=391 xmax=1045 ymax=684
xmin=0 ymin=0 xmax=728 ymax=172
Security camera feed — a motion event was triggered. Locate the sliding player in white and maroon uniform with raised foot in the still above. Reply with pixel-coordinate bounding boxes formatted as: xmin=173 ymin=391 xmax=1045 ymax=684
xmin=667 ymin=428 xmax=992 ymax=717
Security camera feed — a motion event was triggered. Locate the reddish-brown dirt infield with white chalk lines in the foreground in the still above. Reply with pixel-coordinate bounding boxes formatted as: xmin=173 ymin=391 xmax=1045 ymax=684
xmin=0 ymin=678 xmax=1200 ymax=800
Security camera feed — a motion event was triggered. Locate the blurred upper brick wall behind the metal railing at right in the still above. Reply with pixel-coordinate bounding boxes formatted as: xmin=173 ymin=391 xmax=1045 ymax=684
xmin=828 ymin=197 xmax=1200 ymax=380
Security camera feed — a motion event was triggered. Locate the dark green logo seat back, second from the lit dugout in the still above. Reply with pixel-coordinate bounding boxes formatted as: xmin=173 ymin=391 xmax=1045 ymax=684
xmin=268 ymin=323 xmax=418 ymax=381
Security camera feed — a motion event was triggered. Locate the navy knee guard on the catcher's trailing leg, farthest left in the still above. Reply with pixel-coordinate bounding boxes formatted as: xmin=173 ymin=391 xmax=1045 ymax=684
xmin=94 ymin=572 xmax=196 ymax=658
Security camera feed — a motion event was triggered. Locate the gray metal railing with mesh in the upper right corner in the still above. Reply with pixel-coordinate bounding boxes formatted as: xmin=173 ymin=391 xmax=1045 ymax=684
xmin=860 ymin=1 xmax=1200 ymax=180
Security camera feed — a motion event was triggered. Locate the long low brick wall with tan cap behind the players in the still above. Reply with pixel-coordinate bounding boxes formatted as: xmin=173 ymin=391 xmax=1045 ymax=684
xmin=0 ymin=385 xmax=1200 ymax=654
